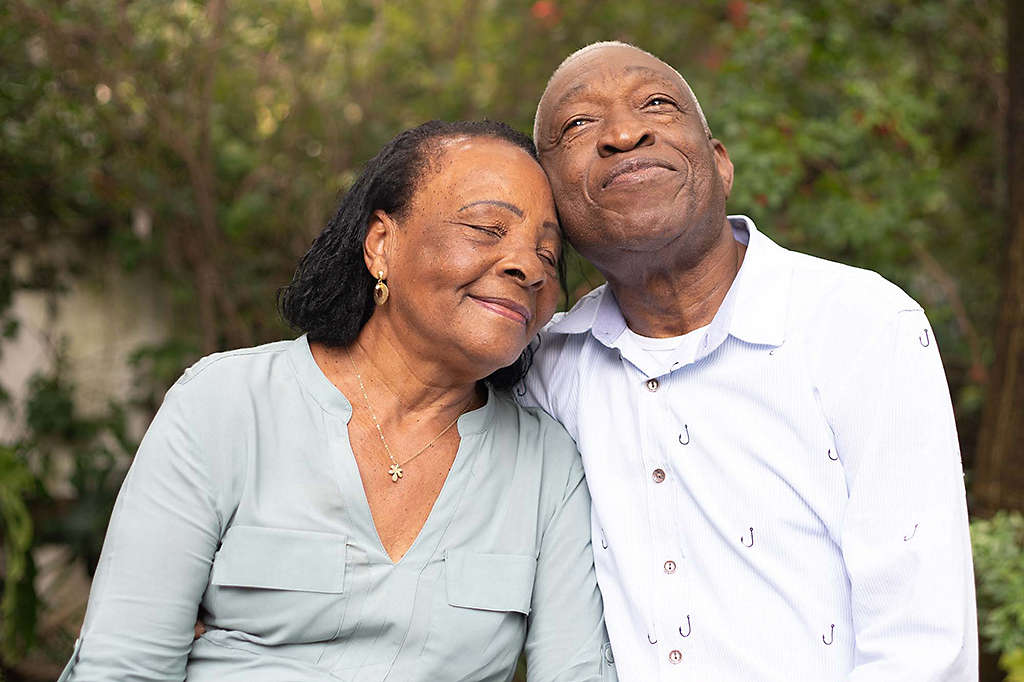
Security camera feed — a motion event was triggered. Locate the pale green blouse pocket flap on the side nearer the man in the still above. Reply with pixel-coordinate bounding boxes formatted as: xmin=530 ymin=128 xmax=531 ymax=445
xmin=444 ymin=550 xmax=537 ymax=615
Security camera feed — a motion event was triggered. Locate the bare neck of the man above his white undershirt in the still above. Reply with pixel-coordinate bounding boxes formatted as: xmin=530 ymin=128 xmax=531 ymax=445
xmin=605 ymin=220 xmax=746 ymax=337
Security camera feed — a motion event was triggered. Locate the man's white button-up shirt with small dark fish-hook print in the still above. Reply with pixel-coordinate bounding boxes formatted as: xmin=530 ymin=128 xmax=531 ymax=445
xmin=521 ymin=216 xmax=978 ymax=682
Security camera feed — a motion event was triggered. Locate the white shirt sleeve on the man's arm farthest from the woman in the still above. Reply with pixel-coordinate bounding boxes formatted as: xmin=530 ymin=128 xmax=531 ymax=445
xmin=823 ymin=309 xmax=978 ymax=682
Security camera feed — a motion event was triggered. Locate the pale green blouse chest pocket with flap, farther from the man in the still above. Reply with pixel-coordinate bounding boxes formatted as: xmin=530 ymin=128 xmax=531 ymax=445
xmin=203 ymin=525 xmax=346 ymax=644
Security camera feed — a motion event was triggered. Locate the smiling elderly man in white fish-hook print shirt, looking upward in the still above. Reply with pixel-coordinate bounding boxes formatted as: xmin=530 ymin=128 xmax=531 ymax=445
xmin=523 ymin=43 xmax=977 ymax=682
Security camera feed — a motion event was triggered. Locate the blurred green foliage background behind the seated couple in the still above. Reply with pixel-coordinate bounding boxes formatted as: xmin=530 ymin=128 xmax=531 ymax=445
xmin=0 ymin=0 xmax=1024 ymax=675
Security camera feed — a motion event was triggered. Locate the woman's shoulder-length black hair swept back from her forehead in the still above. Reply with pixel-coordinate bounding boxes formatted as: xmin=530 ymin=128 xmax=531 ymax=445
xmin=278 ymin=121 xmax=565 ymax=389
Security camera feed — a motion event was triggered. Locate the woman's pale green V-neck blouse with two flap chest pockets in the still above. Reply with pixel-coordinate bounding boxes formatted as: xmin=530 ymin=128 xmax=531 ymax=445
xmin=60 ymin=337 xmax=614 ymax=682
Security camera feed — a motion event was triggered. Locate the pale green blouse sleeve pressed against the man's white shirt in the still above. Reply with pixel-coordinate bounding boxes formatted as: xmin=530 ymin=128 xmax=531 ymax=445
xmin=525 ymin=438 xmax=617 ymax=682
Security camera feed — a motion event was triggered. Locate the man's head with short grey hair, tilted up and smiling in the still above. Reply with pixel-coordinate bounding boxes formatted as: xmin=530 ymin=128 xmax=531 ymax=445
xmin=537 ymin=46 xmax=732 ymax=267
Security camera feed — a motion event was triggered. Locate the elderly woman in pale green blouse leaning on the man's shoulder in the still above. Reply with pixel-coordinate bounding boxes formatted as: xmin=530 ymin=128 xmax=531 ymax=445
xmin=61 ymin=122 xmax=614 ymax=682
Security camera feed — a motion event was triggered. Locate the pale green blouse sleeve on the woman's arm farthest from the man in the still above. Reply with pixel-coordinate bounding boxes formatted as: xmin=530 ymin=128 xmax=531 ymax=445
xmin=60 ymin=382 xmax=221 ymax=682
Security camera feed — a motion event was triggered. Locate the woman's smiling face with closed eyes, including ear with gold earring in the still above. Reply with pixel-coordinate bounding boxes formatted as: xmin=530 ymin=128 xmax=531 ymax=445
xmin=368 ymin=137 xmax=561 ymax=379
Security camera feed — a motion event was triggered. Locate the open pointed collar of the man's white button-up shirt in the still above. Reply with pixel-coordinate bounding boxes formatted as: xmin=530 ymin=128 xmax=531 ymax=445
xmin=547 ymin=215 xmax=792 ymax=356
